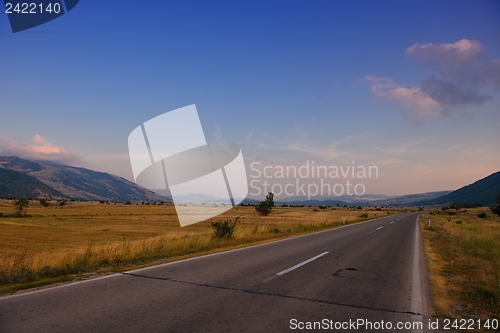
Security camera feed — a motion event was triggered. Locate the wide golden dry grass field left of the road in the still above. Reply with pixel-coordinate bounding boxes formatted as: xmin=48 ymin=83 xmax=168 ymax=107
xmin=0 ymin=200 xmax=408 ymax=293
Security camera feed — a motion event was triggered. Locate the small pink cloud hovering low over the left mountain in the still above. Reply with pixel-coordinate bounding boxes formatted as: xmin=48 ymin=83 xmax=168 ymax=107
xmin=0 ymin=134 xmax=85 ymax=166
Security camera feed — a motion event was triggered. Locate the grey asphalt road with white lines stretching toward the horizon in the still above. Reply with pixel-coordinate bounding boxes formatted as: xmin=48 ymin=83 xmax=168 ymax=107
xmin=0 ymin=213 xmax=434 ymax=333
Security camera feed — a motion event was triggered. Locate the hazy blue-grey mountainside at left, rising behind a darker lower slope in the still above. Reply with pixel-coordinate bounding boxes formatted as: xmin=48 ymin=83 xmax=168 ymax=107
xmin=0 ymin=156 xmax=167 ymax=201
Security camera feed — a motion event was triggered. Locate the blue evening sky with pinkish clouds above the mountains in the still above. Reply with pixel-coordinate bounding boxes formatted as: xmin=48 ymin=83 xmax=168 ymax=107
xmin=0 ymin=0 xmax=500 ymax=195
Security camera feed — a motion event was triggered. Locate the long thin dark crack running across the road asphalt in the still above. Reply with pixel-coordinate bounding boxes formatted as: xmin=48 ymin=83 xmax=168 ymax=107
xmin=121 ymin=273 xmax=422 ymax=316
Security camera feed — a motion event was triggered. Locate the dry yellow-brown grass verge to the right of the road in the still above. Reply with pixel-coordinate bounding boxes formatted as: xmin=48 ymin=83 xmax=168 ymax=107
xmin=420 ymin=208 xmax=500 ymax=320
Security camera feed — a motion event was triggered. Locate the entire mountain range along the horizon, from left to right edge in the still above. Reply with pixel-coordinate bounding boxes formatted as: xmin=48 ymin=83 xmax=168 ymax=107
xmin=0 ymin=156 xmax=500 ymax=206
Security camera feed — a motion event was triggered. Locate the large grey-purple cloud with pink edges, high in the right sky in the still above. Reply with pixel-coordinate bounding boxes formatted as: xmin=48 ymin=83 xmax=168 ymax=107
xmin=365 ymin=39 xmax=500 ymax=123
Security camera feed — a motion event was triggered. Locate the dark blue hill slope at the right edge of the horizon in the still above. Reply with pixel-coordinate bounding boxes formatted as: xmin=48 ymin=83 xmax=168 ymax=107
xmin=416 ymin=171 xmax=500 ymax=206
